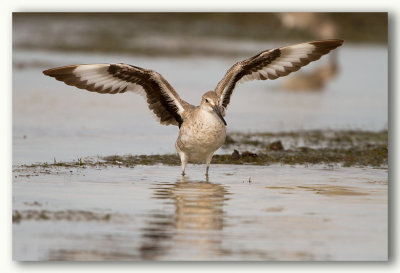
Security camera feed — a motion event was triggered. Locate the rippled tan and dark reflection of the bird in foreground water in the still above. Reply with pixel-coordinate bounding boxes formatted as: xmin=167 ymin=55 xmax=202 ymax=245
xmin=140 ymin=177 xmax=229 ymax=260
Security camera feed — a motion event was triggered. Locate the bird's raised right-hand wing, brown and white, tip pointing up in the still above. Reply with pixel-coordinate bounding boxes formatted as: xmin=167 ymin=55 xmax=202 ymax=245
xmin=215 ymin=40 xmax=343 ymax=107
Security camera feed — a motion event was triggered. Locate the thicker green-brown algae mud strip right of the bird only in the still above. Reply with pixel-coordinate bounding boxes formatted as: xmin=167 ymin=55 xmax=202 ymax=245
xmin=219 ymin=130 xmax=388 ymax=167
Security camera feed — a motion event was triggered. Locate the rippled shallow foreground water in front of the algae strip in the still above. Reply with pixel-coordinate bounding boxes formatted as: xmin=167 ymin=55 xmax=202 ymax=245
xmin=13 ymin=165 xmax=388 ymax=261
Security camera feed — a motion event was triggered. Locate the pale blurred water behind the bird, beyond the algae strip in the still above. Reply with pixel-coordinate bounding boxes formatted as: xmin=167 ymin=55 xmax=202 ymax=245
xmin=13 ymin=43 xmax=388 ymax=164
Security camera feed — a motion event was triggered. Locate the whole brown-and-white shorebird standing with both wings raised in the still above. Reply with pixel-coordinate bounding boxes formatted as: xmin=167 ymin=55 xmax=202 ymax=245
xmin=43 ymin=39 xmax=343 ymax=175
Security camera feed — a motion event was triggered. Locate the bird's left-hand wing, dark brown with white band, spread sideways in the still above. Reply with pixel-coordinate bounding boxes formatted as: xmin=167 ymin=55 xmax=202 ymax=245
xmin=43 ymin=63 xmax=191 ymax=126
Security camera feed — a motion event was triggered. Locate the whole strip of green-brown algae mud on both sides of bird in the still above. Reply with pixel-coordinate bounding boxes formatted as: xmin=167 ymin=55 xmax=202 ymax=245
xmin=14 ymin=130 xmax=388 ymax=170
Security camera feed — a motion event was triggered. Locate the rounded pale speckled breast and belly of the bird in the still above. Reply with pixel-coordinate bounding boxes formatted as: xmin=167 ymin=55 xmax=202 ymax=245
xmin=175 ymin=110 xmax=226 ymax=162
